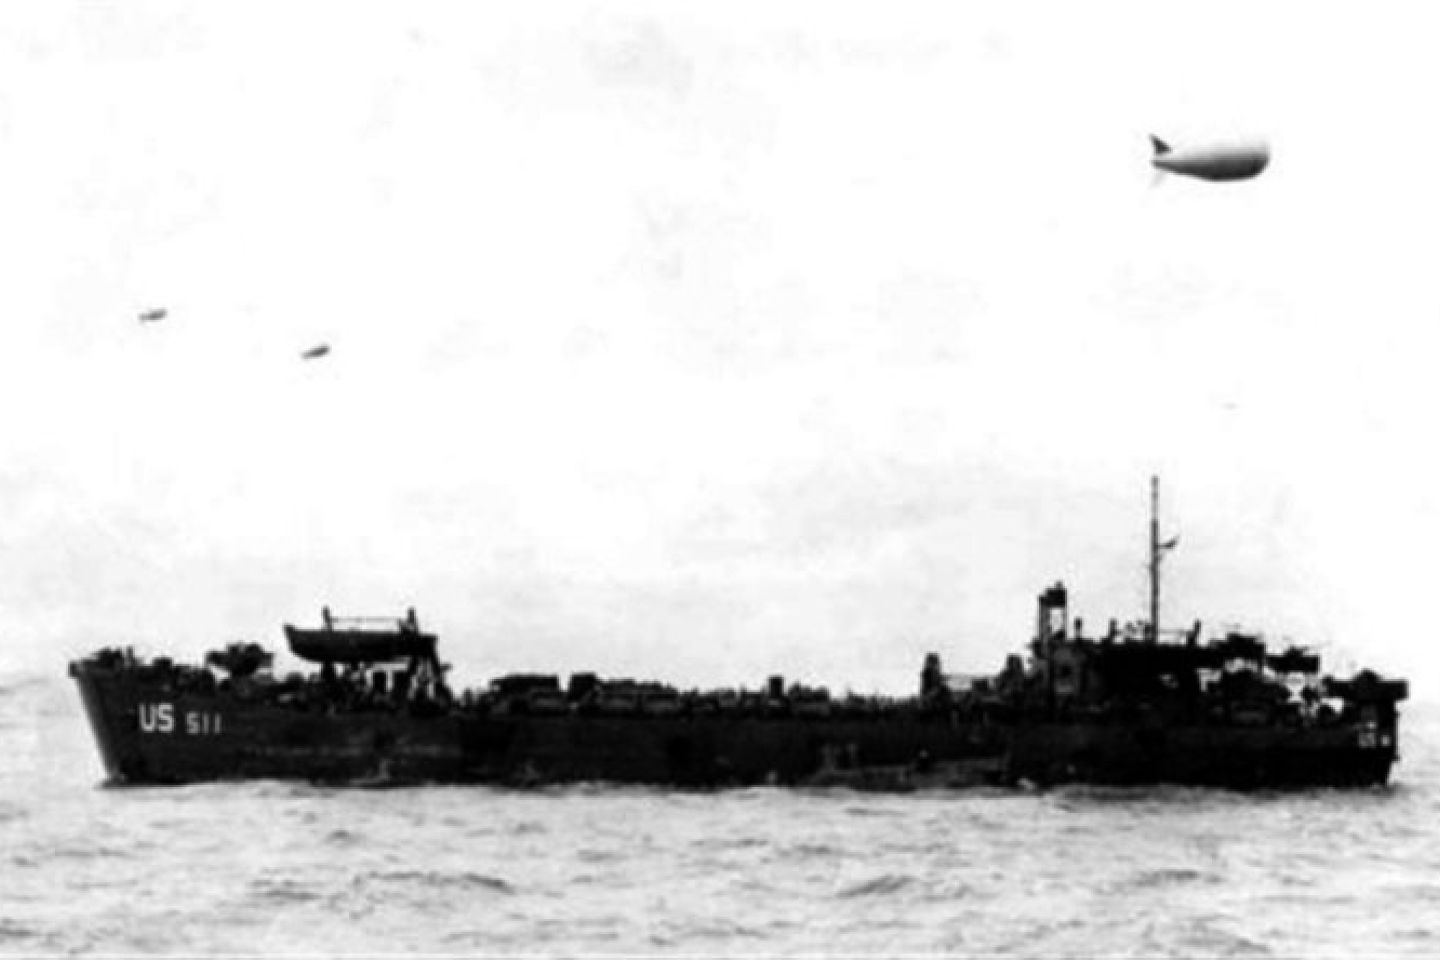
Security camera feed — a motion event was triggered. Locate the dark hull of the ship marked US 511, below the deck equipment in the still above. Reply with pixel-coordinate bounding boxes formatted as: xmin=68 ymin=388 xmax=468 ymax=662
xmin=76 ymin=669 xmax=1395 ymax=789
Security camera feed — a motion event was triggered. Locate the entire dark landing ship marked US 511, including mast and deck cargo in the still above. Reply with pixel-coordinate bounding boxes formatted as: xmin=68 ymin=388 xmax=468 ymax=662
xmin=69 ymin=478 xmax=1408 ymax=790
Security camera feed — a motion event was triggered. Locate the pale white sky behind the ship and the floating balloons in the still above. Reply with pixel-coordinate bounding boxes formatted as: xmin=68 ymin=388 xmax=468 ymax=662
xmin=0 ymin=0 xmax=1440 ymax=697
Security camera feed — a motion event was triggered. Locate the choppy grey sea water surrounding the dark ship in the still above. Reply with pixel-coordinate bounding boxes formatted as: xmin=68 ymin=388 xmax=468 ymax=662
xmin=0 ymin=676 xmax=1440 ymax=957
